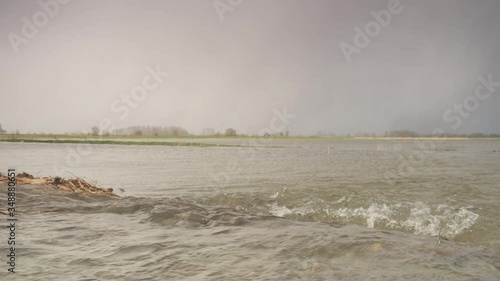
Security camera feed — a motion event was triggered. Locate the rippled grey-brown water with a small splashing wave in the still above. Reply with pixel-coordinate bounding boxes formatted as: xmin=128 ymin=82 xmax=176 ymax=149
xmin=0 ymin=139 xmax=500 ymax=280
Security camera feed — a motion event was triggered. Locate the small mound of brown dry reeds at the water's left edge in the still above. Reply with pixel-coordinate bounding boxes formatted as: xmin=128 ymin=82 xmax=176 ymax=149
xmin=0 ymin=173 xmax=119 ymax=197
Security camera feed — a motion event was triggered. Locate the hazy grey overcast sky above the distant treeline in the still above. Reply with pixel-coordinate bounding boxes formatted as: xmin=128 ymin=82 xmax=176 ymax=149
xmin=0 ymin=0 xmax=500 ymax=134
